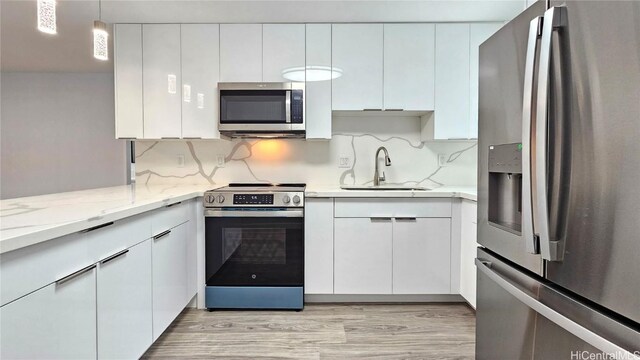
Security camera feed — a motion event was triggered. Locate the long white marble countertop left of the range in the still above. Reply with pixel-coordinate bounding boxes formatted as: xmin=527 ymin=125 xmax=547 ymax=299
xmin=0 ymin=185 xmax=210 ymax=254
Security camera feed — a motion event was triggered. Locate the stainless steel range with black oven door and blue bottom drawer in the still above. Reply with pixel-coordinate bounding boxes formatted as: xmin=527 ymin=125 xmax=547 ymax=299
xmin=204 ymin=184 xmax=305 ymax=310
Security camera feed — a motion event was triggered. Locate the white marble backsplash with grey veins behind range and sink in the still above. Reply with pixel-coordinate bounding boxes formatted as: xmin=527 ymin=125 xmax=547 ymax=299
xmin=136 ymin=117 xmax=477 ymax=188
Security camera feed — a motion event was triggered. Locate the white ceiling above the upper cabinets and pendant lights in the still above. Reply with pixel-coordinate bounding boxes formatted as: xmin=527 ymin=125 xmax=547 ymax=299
xmin=0 ymin=0 xmax=525 ymax=72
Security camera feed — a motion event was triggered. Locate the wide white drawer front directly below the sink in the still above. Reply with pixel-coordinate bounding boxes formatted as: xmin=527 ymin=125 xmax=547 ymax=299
xmin=335 ymin=198 xmax=451 ymax=218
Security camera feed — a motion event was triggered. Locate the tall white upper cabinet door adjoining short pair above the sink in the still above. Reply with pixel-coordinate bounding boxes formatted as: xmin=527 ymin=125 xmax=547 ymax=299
xmin=433 ymin=24 xmax=470 ymax=140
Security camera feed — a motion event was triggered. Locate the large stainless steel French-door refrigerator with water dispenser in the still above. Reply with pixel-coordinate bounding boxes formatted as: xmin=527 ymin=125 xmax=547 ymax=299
xmin=476 ymin=1 xmax=640 ymax=360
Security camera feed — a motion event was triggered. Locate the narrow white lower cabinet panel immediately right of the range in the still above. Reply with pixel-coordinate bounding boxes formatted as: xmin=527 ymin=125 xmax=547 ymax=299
xmin=304 ymin=198 xmax=333 ymax=294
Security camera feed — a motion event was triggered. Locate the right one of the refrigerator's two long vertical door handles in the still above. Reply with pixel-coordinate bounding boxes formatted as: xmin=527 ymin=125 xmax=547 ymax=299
xmin=533 ymin=7 xmax=566 ymax=261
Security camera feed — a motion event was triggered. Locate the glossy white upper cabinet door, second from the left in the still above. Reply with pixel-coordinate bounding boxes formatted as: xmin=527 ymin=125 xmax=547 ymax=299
xmin=142 ymin=24 xmax=182 ymax=139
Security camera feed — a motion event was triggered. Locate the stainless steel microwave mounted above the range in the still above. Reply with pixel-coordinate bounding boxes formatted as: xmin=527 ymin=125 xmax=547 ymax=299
xmin=218 ymin=82 xmax=305 ymax=137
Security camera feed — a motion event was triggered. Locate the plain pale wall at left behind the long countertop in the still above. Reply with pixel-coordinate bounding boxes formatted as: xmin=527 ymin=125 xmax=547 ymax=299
xmin=0 ymin=73 xmax=127 ymax=199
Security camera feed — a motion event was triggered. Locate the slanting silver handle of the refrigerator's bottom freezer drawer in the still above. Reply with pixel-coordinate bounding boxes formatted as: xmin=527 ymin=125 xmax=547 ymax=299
xmin=476 ymin=259 xmax=638 ymax=359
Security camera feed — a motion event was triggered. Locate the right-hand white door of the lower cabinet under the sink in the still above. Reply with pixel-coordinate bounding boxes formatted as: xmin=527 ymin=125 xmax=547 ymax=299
xmin=393 ymin=218 xmax=451 ymax=294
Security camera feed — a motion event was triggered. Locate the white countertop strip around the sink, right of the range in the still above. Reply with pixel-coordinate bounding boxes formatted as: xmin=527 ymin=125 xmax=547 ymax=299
xmin=305 ymin=185 xmax=478 ymax=201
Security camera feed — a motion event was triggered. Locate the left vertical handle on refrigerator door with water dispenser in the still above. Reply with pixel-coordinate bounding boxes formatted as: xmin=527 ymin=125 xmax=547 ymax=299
xmin=522 ymin=16 xmax=542 ymax=254
